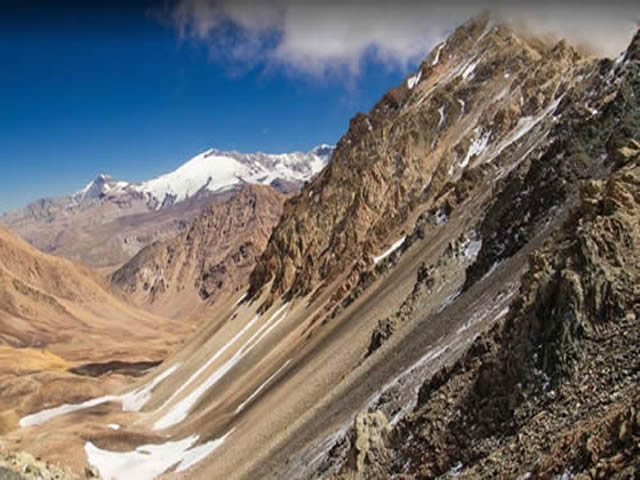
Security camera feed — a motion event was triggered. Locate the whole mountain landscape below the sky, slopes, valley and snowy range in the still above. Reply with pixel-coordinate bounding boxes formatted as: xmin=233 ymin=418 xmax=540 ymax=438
xmin=0 ymin=10 xmax=640 ymax=480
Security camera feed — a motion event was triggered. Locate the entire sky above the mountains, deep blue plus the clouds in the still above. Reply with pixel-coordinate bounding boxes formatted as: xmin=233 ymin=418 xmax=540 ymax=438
xmin=0 ymin=0 xmax=640 ymax=212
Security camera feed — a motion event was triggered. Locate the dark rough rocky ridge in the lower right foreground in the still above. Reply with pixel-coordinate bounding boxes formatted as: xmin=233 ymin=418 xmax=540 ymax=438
xmin=337 ymin=145 xmax=640 ymax=479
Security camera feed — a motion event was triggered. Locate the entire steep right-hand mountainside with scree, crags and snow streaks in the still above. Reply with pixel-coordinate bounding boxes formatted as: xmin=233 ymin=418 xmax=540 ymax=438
xmin=5 ymin=18 xmax=640 ymax=480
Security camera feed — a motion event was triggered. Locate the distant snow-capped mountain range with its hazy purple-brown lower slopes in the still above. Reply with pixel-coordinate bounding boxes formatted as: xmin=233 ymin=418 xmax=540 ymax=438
xmin=0 ymin=145 xmax=333 ymax=271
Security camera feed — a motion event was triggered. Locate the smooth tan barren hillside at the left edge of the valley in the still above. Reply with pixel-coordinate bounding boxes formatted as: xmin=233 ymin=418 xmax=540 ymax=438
xmin=0 ymin=229 xmax=189 ymax=431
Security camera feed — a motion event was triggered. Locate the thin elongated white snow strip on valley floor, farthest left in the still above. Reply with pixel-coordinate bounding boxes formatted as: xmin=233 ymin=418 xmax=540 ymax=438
xmin=20 ymin=363 xmax=181 ymax=427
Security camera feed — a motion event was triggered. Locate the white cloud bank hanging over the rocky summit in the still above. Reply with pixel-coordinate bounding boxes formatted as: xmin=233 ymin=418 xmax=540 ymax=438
xmin=170 ymin=0 xmax=640 ymax=75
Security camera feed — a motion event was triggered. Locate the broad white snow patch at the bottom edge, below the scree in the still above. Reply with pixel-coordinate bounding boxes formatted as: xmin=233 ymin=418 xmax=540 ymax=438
xmin=84 ymin=429 xmax=233 ymax=480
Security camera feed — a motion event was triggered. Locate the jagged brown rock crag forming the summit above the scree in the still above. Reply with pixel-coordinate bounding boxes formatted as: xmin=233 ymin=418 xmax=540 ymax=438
xmin=250 ymin=17 xmax=602 ymax=303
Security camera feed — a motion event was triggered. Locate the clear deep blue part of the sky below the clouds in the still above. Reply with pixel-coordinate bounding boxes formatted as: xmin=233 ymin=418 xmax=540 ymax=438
xmin=0 ymin=2 xmax=424 ymax=212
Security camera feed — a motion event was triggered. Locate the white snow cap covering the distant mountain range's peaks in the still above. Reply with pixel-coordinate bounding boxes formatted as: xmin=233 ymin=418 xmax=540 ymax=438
xmin=71 ymin=144 xmax=335 ymax=209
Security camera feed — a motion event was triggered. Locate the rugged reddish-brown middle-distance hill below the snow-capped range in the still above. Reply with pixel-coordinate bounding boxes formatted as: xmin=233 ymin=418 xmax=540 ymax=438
xmin=110 ymin=185 xmax=285 ymax=318
